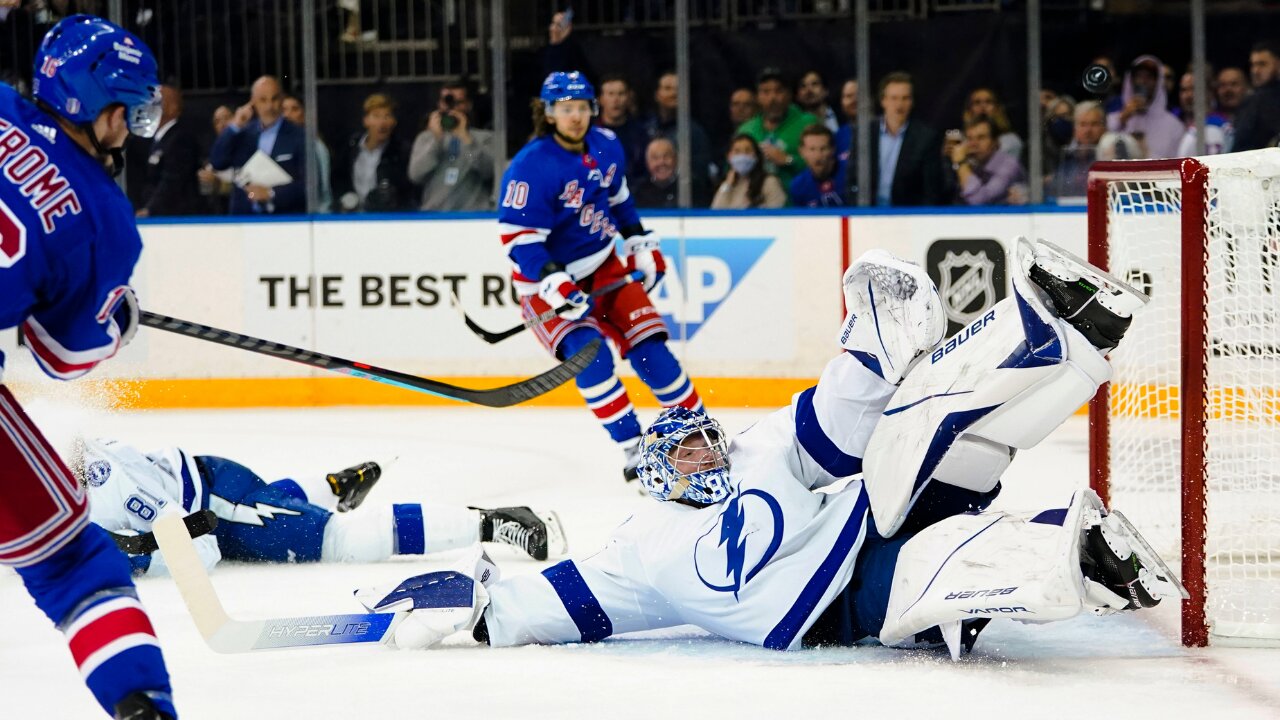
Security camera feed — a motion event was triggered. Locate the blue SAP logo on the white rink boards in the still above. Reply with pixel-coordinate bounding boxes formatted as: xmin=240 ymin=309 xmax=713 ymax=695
xmin=640 ymin=237 xmax=773 ymax=340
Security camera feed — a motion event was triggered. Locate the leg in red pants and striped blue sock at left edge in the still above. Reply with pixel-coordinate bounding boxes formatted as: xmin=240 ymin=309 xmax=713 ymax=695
xmin=0 ymin=386 xmax=177 ymax=716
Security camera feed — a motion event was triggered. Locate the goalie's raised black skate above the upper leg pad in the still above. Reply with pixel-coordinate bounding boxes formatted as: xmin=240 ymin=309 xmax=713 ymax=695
xmin=1018 ymin=237 xmax=1151 ymax=352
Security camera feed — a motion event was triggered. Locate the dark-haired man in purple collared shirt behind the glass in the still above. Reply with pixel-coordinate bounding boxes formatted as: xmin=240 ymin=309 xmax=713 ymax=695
xmin=951 ymin=117 xmax=1027 ymax=205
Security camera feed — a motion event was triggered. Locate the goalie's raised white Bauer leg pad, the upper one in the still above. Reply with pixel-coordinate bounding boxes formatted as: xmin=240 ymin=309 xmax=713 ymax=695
xmin=863 ymin=254 xmax=1111 ymax=537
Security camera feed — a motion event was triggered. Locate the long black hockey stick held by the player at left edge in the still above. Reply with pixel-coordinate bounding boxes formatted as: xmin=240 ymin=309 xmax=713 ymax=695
xmin=142 ymin=310 xmax=600 ymax=407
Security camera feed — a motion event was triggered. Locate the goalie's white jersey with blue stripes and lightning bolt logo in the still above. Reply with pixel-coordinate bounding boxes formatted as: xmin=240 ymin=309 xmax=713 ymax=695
xmin=485 ymin=354 xmax=896 ymax=650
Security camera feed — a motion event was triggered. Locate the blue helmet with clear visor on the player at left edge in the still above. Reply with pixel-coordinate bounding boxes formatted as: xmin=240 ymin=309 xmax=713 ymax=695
xmin=32 ymin=15 xmax=161 ymax=137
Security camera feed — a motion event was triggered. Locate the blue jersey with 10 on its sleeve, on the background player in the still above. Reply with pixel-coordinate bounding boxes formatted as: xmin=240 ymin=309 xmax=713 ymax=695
xmin=498 ymin=127 xmax=640 ymax=295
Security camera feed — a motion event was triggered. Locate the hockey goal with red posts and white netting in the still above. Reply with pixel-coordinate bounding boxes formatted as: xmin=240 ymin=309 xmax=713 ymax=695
xmin=1088 ymin=149 xmax=1280 ymax=646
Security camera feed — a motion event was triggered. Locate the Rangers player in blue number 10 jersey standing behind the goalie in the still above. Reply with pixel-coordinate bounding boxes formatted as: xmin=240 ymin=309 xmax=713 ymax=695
xmin=498 ymin=72 xmax=701 ymax=480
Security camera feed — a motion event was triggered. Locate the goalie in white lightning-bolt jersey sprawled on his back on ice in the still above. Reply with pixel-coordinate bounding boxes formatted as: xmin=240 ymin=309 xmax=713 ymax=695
xmin=357 ymin=240 xmax=1183 ymax=656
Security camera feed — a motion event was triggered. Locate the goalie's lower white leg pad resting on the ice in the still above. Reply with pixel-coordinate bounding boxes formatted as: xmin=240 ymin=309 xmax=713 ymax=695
xmin=879 ymin=489 xmax=1105 ymax=644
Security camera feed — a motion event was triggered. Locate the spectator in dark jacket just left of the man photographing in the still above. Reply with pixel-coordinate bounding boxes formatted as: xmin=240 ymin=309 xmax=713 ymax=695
xmin=333 ymin=92 xmax=413 ymax=213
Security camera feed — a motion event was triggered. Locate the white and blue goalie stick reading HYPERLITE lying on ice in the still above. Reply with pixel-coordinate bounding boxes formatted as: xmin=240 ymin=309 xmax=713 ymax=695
xmin=152 ymin=515 xmax=408 ymax=652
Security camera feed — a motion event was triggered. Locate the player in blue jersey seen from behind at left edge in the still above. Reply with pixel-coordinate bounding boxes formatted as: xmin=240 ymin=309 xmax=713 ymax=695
xmin=0 ymin=15 xmax=177 ymax=720
